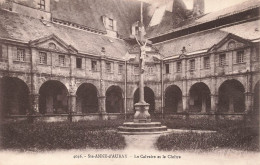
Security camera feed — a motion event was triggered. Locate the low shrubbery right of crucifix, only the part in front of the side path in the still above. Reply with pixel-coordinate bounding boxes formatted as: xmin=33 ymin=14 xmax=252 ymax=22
xmin=156 ymin=127 xmax=259 ymax=151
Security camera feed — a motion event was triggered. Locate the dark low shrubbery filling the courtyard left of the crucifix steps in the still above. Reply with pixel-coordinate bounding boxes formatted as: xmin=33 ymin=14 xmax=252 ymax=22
xmin=1 ymin=121 xmax=126 ymax=151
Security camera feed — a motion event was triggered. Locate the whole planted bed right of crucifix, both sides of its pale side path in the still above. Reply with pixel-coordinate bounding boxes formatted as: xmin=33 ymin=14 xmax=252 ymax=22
xmin=156 ymin=120 xmax=259 ymax=151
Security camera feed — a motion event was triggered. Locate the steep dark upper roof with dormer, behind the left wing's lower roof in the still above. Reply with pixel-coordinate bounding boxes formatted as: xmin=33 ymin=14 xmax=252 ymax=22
xmin=51 ymin=0 xmax=140 ymax=38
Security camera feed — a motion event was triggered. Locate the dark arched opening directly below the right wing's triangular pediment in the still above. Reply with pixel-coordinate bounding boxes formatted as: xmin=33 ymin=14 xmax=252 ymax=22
xmin=218 ymin=80 xmax=245 ymax=112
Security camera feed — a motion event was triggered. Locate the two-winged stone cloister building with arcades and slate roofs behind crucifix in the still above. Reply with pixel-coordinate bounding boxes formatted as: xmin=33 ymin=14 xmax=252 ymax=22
xmin=0 ymin=0 xmax=260 ymax=121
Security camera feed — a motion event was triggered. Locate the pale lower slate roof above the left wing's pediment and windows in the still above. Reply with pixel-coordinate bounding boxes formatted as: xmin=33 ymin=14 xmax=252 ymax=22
xmin=0 ymin=9 xmax=127 ymax=59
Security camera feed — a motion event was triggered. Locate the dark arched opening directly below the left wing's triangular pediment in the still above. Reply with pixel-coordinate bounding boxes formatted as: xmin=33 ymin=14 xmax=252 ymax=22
xmin=39 ymin=80 xmax=68 ymax=114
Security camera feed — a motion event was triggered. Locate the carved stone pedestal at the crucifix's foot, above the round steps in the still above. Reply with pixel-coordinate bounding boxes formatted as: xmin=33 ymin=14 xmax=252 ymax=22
xmin=134 ymin=103 xmax=151 ymax=123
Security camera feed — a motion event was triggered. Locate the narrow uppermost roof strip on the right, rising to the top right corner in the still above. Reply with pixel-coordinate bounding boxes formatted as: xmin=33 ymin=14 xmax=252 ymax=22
xmin=147 ymin=0 xmax=260 ymax=38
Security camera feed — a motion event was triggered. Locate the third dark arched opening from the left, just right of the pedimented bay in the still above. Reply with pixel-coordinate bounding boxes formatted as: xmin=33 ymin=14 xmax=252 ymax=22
xmin=76 ymin=83 xmax=98 ymax=113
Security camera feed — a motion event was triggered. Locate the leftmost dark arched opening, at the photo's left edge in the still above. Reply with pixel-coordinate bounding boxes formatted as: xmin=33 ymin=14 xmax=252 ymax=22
xmin=0 ymin=77 xmax=30 ymax=116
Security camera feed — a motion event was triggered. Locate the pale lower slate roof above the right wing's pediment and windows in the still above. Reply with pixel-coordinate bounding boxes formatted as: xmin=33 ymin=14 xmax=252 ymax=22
xmin=154 ymin=20 xmax=260 ymax=58
